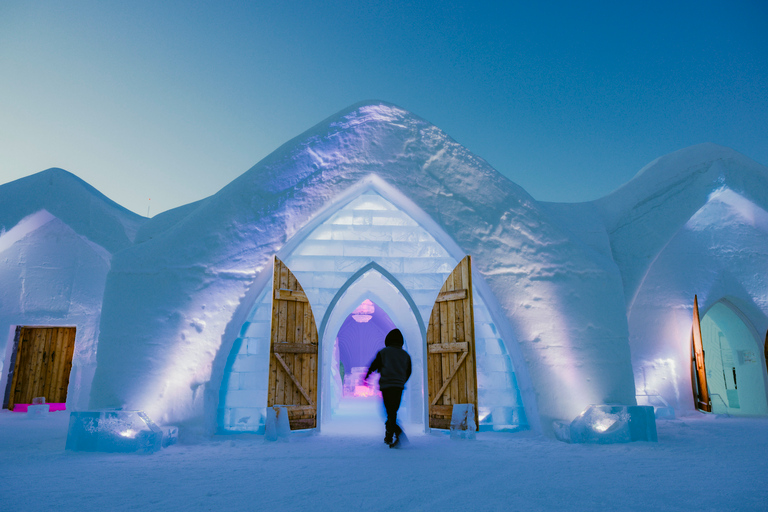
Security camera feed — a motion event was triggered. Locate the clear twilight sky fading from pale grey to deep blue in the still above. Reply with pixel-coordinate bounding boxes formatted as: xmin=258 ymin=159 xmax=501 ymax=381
xmin=0 ymin=0 xmax=768 ymax=215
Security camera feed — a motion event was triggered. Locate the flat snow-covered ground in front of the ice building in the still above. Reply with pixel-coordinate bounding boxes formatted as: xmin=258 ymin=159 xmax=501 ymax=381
xmin=0 ymin=406 xmax=768 ymax=512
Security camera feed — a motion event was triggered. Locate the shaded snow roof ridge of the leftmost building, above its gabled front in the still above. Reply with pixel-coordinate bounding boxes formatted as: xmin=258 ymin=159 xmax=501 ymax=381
xmin=0 ymin=167 xmax=146 ymax=253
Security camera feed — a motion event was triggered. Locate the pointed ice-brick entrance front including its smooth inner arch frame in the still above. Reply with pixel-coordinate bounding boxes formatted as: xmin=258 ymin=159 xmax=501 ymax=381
xmin=216 ymin=188 xmax=535 ymax=432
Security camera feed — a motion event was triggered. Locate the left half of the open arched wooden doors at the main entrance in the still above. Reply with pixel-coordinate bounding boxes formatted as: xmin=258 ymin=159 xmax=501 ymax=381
xmin=267 ymin=257 xmax=318 ymax=430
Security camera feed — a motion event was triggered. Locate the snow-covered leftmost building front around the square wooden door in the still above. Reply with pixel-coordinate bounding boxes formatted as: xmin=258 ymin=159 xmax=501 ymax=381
xmin=0 ymin=169 xmax=141 ymax=408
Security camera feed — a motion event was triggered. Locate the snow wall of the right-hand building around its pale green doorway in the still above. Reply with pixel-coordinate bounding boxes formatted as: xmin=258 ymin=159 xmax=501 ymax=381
xmin=594 ymin=144 xmax=768 ymax=411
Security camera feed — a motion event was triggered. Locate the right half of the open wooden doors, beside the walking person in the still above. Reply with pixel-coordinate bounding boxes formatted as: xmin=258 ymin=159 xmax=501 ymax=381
xmin=427 ymin=256 xmax=478 ymax=429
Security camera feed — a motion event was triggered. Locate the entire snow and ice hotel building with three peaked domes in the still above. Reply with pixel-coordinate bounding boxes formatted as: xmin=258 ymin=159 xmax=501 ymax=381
xmin=0 ymin=102 xmax=768 ymax=433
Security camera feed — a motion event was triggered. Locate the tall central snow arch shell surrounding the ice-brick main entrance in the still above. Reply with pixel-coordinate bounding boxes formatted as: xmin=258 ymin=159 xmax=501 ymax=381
xmin=91 ymin=102 xmax=634 ymax=431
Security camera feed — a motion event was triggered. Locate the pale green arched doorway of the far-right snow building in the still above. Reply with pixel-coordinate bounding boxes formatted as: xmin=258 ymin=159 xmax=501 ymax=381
xmin=701 ymin=299 xmax=768 ymax=415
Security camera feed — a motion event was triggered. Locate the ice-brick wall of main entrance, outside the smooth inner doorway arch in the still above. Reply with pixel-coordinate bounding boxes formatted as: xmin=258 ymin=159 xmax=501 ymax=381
xmin=219 ymin=191 xmax=525 ymax=432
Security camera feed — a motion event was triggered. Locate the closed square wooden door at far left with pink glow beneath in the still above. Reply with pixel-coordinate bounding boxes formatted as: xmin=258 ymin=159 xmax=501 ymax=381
xmin=8 ymin=327 xmax=75 ymax=409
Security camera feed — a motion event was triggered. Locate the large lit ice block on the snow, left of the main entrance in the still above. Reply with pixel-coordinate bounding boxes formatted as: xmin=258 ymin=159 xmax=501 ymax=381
xmin=66 ymin=410 xmax=163 ymax=453
